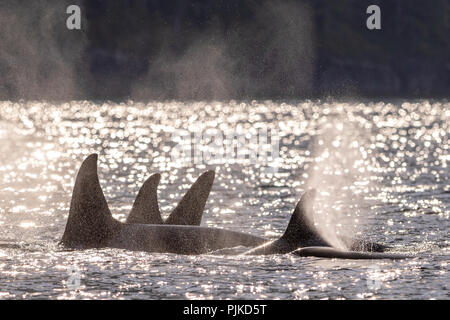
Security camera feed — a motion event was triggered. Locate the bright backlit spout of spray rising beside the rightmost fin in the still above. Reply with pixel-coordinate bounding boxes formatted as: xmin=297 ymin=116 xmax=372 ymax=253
xmin=304 ymin=110 xmax=379 ymax=249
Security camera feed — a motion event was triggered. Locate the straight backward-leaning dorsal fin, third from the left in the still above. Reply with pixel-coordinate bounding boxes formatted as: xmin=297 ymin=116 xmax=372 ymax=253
xmin=166 ymin=171 xmax=215 ymax=226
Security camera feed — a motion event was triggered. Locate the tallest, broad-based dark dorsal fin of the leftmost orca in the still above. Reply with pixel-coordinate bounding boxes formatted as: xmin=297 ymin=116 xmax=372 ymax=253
xmin=61 ymin=154 xmax=120 ymax=248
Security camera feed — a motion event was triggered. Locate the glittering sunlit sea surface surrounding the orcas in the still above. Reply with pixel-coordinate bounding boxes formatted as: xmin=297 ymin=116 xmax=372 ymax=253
xmin=0 ymin=100 xmax=450 ymax=299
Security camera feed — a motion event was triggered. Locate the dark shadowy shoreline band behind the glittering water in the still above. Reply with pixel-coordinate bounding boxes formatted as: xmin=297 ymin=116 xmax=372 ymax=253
xmin=0 ymin=0 xmax=450 ymax=100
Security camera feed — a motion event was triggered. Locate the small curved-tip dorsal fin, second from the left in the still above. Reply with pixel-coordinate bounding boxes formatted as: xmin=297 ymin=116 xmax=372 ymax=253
xmin=127 ymin=173 xmax=164 ymax=224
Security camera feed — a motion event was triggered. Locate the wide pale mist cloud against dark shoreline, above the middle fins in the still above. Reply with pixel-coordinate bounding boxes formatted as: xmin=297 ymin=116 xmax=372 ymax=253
xmin=131 ymin=1 xmax=315 ymax=101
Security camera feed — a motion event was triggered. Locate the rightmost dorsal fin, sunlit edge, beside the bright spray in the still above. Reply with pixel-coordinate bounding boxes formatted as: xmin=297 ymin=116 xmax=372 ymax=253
xmin=281 ymin=189 xmax=326 ymax=246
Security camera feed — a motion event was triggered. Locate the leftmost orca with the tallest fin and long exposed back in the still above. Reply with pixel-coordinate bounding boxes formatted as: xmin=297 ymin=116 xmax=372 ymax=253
xmin=60 ymin=154 xmax=266 ymax=254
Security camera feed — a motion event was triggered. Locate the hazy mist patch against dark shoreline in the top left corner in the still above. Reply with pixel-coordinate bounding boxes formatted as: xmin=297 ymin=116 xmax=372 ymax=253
xmin=0 ymin=0 xmax=87 ymax=100
